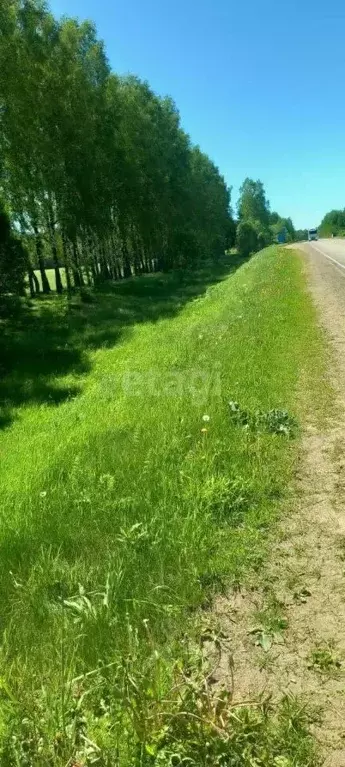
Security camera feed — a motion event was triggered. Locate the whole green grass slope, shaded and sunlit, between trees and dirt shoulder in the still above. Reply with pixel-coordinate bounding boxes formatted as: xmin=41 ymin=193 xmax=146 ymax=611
xmin=0 ymin=247 xmax=324 ymax=767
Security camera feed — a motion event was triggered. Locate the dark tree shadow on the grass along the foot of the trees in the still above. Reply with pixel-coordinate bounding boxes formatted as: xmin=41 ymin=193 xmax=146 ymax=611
xmin=0 ymin=255 xmax=244 ymax=429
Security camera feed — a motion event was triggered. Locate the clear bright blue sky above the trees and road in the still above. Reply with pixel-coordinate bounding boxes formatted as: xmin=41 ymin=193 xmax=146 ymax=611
xmin=51 ymin=0 xmax=345 ymax=227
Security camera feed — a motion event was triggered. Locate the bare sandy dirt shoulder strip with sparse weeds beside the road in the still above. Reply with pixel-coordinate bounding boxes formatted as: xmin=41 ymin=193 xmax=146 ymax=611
xmin=207 ymin=248 xmax=345 ymax=767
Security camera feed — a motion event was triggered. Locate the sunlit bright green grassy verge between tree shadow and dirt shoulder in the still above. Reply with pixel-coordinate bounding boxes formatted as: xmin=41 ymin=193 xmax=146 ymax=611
xmin=0 ymin=247 xmax=329 ymax=767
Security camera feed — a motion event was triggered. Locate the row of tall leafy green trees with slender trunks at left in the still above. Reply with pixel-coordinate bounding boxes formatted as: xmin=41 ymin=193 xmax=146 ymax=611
xmin=0 ymin=0 xmax=295 ymax=297
